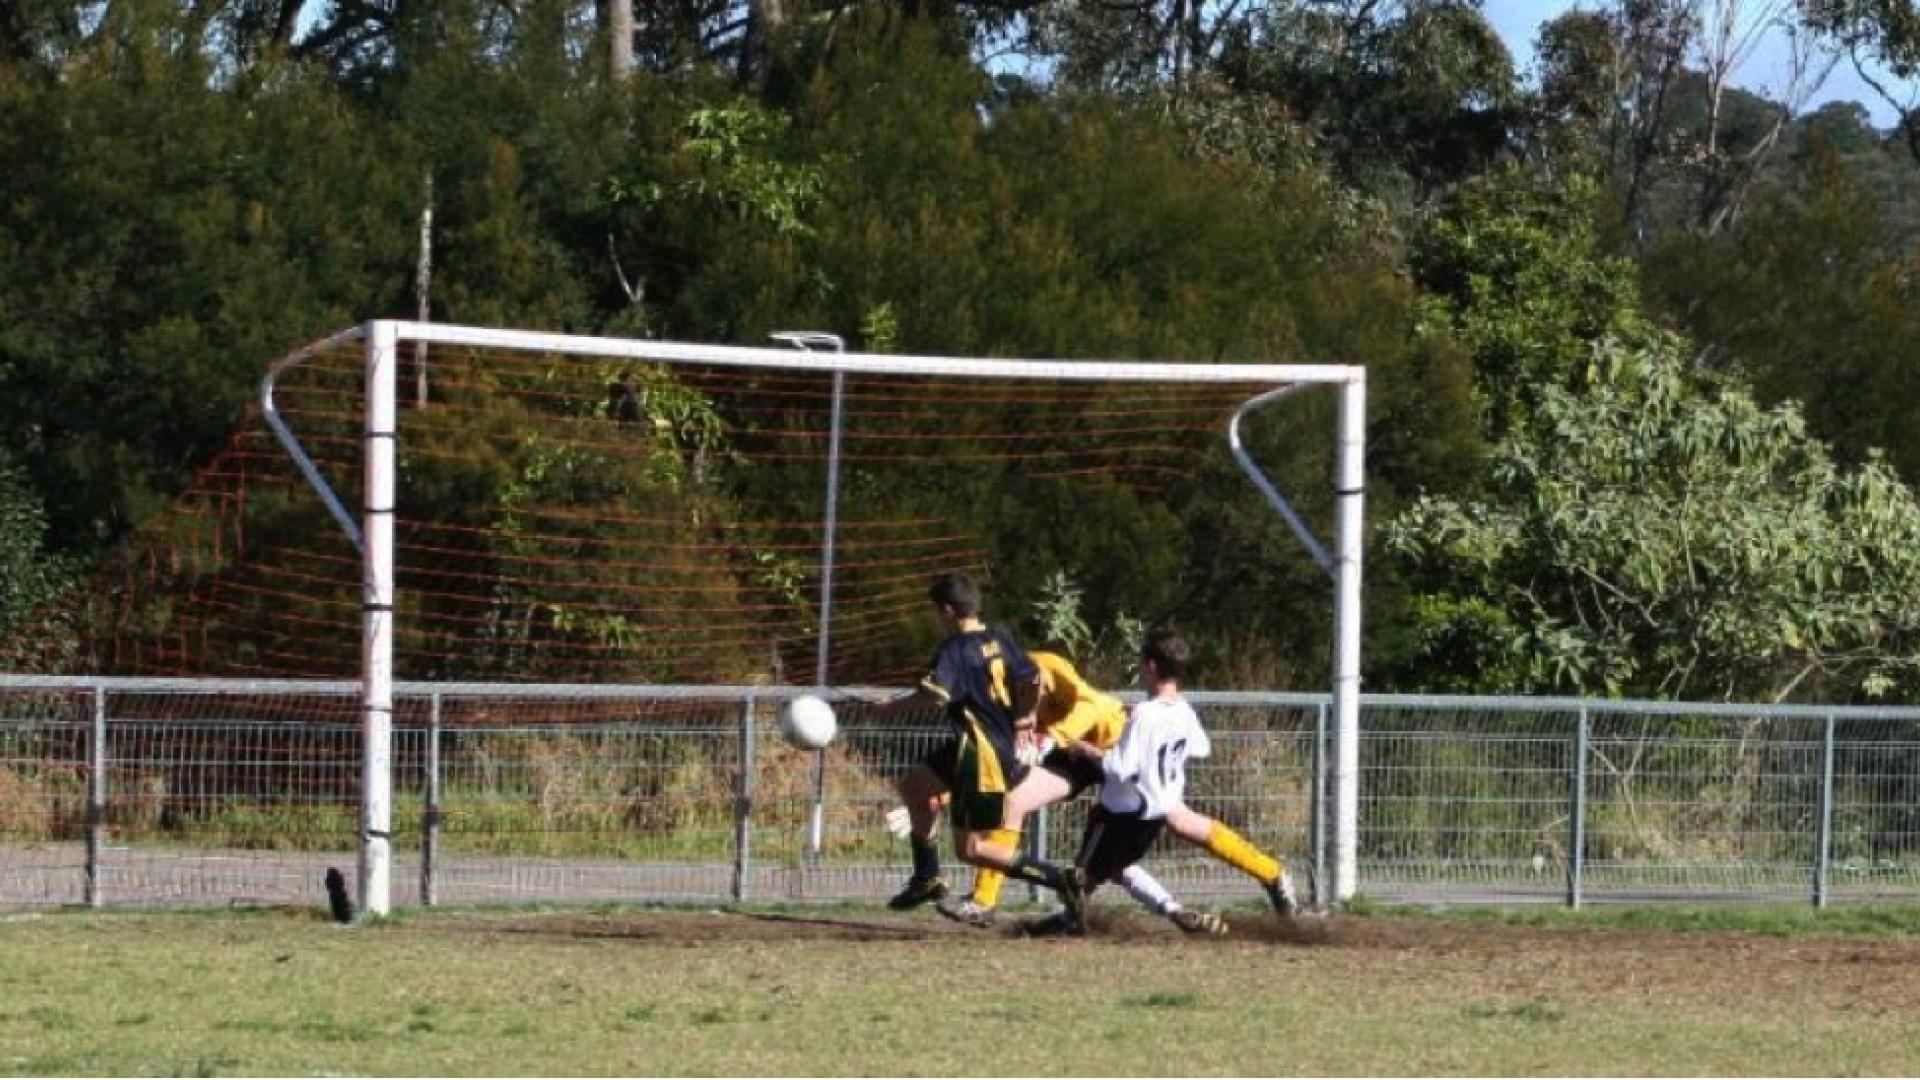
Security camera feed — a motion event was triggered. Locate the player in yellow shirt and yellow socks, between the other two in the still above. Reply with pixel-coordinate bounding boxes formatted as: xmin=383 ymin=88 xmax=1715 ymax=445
xmin=921 ymin=651 xmax=1296 ymax=934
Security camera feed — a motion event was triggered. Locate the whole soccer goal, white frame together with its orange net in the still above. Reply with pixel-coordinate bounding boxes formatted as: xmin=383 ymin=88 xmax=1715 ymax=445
xmin=263 ymin=321 xmax=1365 ymax=915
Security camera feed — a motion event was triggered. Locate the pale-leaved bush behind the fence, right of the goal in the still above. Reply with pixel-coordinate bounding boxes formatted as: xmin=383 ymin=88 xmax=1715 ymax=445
xmin=1386 ymin=340 xmax=1920 ymax=700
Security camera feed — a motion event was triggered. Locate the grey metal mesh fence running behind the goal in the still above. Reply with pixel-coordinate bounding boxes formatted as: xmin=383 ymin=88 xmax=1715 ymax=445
xmin=0 ymin=676 xmax=1920 ymax=907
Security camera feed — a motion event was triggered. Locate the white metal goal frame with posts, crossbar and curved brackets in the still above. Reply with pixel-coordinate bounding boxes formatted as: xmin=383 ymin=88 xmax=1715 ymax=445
xmin=261 ymin=319 xmax=1367 ymax=915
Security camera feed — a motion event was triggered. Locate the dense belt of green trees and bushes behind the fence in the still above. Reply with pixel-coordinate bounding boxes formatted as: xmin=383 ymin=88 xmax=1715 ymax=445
xmin=0 ymin=0 xmax=1920 ymax=694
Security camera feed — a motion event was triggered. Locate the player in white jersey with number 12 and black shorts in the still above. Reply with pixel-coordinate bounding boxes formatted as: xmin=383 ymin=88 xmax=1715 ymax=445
xmin=1029 ymin=630 xmax=1296 ymax=934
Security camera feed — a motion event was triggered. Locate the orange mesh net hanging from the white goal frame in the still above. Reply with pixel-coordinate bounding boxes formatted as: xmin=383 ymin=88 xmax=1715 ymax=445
xmin=22 ymin=332 xmax=1325 ymax=684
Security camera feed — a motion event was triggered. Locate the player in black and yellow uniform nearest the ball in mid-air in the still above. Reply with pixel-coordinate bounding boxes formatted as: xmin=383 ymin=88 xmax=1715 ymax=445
xmin=872 ymin=575 xmax=1079 ymax=913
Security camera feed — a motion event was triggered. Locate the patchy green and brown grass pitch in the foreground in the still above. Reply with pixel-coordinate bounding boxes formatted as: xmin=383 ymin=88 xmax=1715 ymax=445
xmin=0 ymin=909 xmax=1920 ymax=1074
